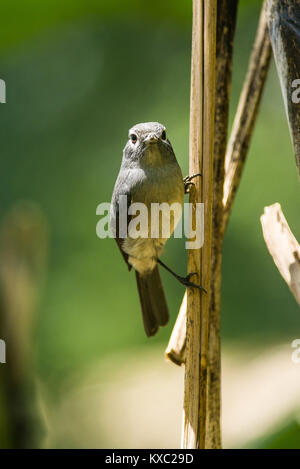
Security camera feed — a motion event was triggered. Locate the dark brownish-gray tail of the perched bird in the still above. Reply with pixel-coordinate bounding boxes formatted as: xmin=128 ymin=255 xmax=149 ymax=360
xmin=136 ymin=266 xmax=169 ymax=337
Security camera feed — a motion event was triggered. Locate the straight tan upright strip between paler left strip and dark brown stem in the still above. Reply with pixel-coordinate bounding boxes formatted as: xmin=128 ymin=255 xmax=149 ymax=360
xmin=199 ymin=0 xmax=217 ymax=448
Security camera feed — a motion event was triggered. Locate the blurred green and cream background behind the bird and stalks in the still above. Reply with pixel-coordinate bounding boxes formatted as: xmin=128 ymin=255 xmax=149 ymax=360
xmin=0 ymin=0 xmax=300 ymax=448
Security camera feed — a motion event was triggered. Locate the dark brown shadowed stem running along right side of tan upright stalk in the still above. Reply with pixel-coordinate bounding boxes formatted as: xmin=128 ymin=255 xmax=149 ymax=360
xmin=205 ymin=0 xmax=238 ymax=449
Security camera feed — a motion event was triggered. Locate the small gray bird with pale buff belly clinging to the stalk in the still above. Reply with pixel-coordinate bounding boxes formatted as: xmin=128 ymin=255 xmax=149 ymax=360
xmin=110 ymin=122 xmax=202 ymax=337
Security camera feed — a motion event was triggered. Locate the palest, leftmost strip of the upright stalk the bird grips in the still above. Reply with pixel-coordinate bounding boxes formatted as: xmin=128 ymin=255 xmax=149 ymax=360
xmin=182 ymin=0 xmax=204 ymax=448
